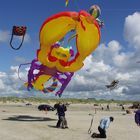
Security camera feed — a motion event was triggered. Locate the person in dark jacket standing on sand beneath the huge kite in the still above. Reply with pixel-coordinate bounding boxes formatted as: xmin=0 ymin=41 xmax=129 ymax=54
xmin=54 ymin=102 xmax=68 ymax=129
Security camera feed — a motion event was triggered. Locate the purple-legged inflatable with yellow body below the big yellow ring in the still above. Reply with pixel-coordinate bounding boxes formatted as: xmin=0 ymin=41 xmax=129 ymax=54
xmin=26 ymin=56 xmax=74 ymax=96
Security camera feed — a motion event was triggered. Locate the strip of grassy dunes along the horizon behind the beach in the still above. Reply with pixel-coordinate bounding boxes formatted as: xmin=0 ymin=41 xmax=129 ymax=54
xmin=0 ymin=97 xmax=137 ymax=104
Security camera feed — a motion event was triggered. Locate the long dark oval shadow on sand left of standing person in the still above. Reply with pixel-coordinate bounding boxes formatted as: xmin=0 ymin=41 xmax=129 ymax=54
xmin=3 ymin=115 xmax=57 ymax=122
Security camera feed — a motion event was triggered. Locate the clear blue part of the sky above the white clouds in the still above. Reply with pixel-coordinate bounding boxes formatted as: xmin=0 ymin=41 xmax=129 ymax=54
xmin=0 ymin=0 xmax=140 ymax=100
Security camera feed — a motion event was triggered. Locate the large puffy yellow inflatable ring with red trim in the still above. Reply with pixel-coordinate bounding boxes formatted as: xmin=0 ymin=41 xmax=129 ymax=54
xmin=37 ymin=11 xmax=100 ymax=72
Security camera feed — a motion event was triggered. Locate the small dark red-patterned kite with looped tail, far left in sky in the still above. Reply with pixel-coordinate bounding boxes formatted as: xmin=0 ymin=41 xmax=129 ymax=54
xmin=10 ymin=26 xmax=27 ymax=50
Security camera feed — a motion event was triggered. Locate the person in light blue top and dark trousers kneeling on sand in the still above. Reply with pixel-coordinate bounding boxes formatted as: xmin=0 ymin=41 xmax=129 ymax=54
xmin=91 ymin=117 xmax=114 ymax=138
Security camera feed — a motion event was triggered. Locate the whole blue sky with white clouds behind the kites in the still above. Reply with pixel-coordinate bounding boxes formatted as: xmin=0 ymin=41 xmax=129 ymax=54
xmin=0 ymin=0 xmax=140 ymax=100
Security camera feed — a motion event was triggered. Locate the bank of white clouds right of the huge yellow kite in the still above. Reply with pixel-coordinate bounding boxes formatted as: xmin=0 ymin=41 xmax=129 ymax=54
xmin=64 ymin=13 xmax=140 ymax=100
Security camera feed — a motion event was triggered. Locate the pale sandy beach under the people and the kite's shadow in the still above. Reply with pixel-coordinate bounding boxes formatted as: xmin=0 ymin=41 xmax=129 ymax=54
xmin=0 ymin=103 xmax=140 ymax=140
